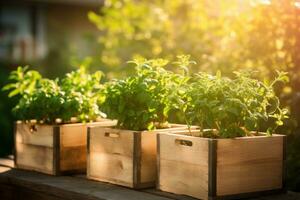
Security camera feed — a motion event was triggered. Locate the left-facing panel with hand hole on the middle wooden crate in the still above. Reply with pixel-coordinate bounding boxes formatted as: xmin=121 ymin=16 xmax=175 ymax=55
xmin=88 ymin=127 xmax=134 ymax=187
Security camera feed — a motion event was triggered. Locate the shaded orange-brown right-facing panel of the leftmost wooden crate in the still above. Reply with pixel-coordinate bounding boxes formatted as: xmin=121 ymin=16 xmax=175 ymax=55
xmin=59 ymin=124 xmax=87 ymax=172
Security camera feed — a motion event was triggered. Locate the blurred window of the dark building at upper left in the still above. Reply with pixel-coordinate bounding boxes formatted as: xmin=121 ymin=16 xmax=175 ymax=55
xmin=0 ymin=6 xmax=46 ymax=61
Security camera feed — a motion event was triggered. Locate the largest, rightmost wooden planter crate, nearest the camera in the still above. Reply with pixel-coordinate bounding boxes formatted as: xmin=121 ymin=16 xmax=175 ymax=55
xmin=157 ymin=131 xmax=286 ymax=199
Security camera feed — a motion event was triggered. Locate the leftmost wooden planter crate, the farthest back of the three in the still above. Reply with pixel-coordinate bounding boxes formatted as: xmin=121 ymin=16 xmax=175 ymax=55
xmin=14 ymin=120 xmax=116 ymax=175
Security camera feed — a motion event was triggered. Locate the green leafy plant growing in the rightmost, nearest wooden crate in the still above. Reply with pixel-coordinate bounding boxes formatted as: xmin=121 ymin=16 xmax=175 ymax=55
xmin=182 ymin=72 xmax=288 ymax=138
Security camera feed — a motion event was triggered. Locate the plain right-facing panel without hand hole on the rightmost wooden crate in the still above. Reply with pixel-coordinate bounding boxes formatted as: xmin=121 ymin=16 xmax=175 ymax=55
xmin=216 ymin=136 xmax=284 ymax=196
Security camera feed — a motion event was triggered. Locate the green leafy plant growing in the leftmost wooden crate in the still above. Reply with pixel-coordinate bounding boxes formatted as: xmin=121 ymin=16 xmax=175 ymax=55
xmin=3 ymin=67 xmax=103 ymax=124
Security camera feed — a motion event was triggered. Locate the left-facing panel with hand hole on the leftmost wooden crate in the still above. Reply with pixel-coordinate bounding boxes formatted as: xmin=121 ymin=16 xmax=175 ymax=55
xmin=15 ymin=123 xmax=54 ymax=174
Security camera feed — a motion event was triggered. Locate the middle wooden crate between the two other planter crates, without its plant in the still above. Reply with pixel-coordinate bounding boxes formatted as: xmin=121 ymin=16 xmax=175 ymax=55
xmin=87 ymin=125 xmax=190 ymax=189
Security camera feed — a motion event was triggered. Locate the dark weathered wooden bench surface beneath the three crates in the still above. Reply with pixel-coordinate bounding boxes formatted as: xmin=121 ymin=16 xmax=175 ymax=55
xmin=0 ymin=158 xmax=300 ymax=200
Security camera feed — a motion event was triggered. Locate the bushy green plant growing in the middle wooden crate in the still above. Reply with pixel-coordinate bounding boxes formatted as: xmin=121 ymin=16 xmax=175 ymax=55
xmin=101 ymin=58 xmax=187 ymax=130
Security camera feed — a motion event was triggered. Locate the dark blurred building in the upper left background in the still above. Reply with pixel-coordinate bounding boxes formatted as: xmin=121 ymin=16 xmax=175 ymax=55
xmin=0 ymin=0 xmax=103 ymax=68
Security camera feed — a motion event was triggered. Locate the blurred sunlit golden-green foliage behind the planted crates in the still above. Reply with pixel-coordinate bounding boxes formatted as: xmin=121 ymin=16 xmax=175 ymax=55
xmin=0 ymin=0 xmax=300 ymax=191
